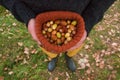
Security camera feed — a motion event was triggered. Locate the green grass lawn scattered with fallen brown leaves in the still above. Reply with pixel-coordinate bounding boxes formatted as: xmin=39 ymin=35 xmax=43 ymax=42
xmin=0 ymin=0 xmax=120 ymax=80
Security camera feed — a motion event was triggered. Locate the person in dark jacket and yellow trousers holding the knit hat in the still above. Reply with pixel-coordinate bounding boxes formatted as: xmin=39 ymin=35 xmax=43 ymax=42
xmin=0 ymin=0 xmax=115 ymax=72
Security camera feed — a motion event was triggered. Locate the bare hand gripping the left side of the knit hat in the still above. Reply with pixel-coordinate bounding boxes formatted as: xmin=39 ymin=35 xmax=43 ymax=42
xmin=28 ymin=18 xmax=41 ymax=45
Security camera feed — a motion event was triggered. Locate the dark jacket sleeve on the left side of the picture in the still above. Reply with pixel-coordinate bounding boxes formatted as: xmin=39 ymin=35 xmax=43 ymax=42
xmin=0 ymin=0 xmax=35 ymax=25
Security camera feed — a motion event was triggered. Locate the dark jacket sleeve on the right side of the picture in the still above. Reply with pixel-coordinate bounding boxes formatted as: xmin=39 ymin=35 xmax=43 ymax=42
xmin=82 ymin=0 xmax=115 ymax=34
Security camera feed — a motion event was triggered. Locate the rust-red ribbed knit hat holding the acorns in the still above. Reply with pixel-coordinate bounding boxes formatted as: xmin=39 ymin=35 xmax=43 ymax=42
xmin=35 ymin=11 xmax=85 ymax=53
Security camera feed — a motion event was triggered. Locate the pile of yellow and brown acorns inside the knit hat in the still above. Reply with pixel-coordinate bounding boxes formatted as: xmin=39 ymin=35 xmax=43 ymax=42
xmin=42 ymin=20 xmax=77 ymax=45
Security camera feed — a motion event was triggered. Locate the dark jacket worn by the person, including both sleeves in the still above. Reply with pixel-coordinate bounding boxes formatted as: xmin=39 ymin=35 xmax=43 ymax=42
xmin=0 ymin=0 xmax=115 ymax=33
